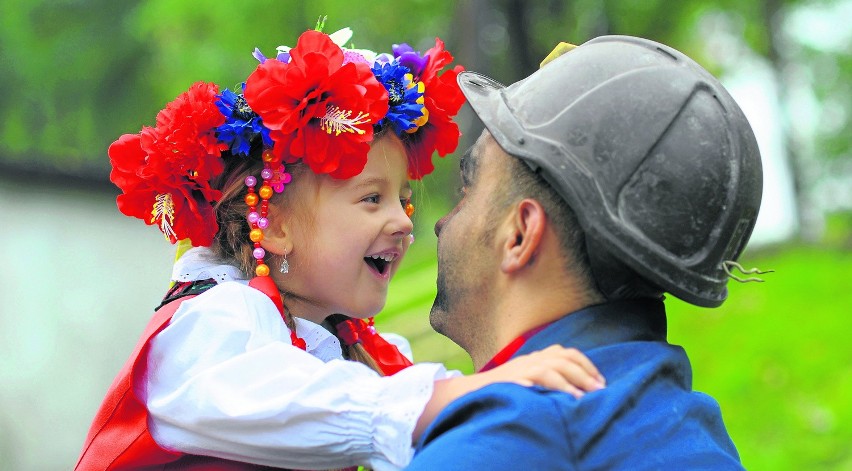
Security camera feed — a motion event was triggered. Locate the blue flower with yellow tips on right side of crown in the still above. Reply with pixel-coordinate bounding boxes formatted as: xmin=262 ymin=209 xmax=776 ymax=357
xmin=373 ymin=61 xmax=425 ymax=136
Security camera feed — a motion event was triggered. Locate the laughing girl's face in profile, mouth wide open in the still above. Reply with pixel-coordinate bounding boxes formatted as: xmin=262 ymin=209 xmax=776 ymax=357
xmin=277 ymin=133 xmax=413 ymax=322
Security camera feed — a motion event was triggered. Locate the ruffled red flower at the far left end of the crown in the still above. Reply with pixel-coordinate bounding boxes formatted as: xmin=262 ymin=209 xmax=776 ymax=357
xmin=108 ymin=82 xmax=227 ymax=246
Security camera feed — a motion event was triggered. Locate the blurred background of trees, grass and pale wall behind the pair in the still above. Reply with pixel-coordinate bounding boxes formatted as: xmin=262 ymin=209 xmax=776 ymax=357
xmin=0 ymin=0 xmax=852 ymax=470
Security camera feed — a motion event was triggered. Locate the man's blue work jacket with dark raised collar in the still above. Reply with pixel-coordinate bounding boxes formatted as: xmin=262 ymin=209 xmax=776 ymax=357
xmin=407 ymin=300 xmax=742 ymax=471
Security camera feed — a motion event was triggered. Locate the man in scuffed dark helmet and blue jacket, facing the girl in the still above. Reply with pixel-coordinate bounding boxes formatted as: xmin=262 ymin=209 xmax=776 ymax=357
xmin=409 ymin=36 xmax=762 ymax=471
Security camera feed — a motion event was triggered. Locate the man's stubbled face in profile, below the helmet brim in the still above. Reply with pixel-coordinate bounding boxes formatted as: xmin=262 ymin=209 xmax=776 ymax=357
xmin=429 ymin=131 xmax=503 ymax=351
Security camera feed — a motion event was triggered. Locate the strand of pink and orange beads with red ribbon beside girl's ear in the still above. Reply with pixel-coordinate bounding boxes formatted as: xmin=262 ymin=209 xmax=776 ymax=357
xmin=245 ymin=149 xmax=307 ymax=350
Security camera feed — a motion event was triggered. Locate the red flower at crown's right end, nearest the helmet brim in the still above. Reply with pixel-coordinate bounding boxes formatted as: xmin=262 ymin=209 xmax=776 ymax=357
xmin=406 ymin=38 xmax=465 ymax=180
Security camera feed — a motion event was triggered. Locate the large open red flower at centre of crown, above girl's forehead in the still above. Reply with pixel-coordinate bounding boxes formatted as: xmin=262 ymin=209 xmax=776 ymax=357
xmin=244 ymin=30 xmax=388 ymax=178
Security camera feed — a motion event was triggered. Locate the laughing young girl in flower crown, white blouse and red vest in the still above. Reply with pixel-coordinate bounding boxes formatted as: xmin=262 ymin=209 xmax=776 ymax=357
xmin=77 ymin=24 xmax=602 ymax=470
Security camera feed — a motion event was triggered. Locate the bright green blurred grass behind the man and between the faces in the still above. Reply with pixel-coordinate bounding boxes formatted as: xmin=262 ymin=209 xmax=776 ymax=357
xmin=377 ymin=215 xmax=852 ymax=470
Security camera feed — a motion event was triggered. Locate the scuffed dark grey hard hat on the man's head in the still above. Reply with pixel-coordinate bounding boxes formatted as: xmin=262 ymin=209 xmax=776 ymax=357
xmin=458 ymin=36 xmax=763 ymax=307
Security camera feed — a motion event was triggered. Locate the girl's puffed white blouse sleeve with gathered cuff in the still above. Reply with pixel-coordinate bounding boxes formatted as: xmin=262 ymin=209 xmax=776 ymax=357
xmin=141 ymin=282 xmax=451 ymax=470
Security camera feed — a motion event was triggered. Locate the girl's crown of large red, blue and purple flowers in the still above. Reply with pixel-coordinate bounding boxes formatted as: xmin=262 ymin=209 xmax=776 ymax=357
xmin=109 ymin=25 xmax=464 ymax=247
